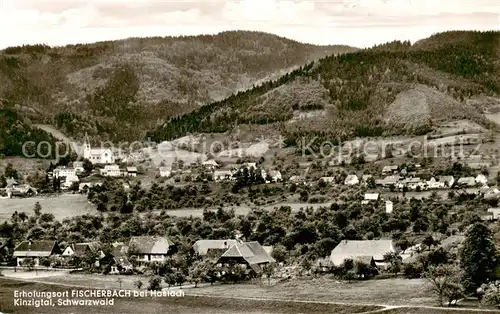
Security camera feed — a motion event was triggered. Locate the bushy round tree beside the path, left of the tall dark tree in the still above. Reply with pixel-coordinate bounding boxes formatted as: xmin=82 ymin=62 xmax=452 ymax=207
xmin=423 ymin=265 xmax=465 ymax=306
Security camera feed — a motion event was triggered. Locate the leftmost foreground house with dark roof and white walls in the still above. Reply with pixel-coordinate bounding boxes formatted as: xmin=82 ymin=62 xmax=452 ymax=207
xmin=13 ymin=240 xmax=62 ymax=266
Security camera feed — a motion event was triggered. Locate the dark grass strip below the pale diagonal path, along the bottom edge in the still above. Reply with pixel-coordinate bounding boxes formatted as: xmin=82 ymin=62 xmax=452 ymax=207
xmin=0 ymin=278 xmax=382 ymax=314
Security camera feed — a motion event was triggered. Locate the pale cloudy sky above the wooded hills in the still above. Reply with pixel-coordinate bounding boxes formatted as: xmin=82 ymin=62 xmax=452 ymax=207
xmin=0 ymin=0 xmax=500 ymax=49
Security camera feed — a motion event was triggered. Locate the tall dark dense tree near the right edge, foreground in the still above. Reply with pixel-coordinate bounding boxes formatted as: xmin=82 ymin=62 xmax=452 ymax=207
xmin=460 ymin=223 xmax=496 ymax=293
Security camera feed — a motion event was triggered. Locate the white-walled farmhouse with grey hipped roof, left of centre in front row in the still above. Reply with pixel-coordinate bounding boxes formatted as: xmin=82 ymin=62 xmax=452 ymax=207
xmin=129 ymin=236 xmax=175 ymax=262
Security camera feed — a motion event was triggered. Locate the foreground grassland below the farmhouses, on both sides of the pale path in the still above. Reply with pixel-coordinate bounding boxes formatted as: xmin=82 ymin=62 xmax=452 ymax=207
xmin=0 ymin=275 xmax=500 ymax=314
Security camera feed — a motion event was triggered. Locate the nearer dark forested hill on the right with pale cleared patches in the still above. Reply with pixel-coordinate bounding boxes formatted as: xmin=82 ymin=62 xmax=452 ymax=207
xmin=149 ymin=31 xmax=500 ymax=143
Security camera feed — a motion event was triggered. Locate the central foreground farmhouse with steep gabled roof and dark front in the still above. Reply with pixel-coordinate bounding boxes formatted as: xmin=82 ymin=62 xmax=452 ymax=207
xmin=218 ymin=242 xmax=276 ymax=274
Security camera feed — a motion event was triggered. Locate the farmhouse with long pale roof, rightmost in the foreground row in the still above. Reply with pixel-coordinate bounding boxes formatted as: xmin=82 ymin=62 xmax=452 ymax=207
xmin=330 ymin=240 xmax=396 ymax=267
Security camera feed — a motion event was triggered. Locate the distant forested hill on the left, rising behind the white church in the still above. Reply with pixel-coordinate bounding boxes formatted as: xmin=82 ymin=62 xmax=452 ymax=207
xmin=0 ymin=31 xmax=356 ymax=140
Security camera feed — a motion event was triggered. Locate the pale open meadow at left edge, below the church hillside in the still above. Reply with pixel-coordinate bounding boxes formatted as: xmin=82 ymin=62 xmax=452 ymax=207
xmin=0 ymin=194 xmax=97 ymax=221
